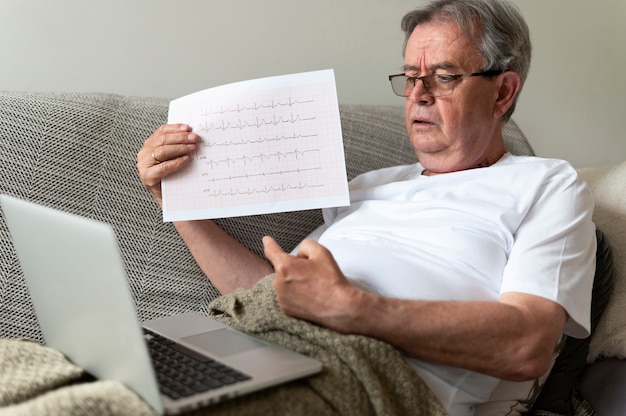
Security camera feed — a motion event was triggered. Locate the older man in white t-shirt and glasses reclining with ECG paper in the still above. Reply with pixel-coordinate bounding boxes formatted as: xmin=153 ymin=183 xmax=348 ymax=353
xmin=138 ymin=0 xmax=595 ymax=415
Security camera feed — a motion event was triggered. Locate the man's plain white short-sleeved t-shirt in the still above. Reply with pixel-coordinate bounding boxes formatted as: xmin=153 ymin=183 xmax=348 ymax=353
xmin=314 ymin=154 xmax=596 ymax=416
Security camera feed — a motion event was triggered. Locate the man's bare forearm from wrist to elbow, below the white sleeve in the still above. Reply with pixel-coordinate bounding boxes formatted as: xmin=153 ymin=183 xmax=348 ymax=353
xmin=337 ymin=292 xmax=566 ymax=381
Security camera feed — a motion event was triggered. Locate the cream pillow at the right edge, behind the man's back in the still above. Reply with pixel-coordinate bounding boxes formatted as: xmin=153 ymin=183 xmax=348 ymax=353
xmin=578 ymin=162 xmax=626 ymax=362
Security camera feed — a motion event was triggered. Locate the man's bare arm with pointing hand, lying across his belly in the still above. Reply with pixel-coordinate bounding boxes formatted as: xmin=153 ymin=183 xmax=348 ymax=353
xmin=264 ymin=237 xmax=567 ymax=381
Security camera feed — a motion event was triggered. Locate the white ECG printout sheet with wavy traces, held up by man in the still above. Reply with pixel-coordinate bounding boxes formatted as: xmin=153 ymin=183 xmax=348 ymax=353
xmin=162 ymin=70 xmax=350 ymax=221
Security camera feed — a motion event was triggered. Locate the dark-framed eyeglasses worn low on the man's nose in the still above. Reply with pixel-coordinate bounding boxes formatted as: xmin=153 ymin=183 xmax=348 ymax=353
xmin=389 ymin=69 xmax=502 ymax=97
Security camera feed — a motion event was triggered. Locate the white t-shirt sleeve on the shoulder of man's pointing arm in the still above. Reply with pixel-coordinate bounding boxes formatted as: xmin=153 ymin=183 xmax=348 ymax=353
xmin=501 ymin=163 xmax=596 ymax=338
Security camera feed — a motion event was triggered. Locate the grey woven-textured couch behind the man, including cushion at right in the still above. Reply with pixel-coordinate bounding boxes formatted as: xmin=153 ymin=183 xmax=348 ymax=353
xmin=0 ymin=92 xmax=626 ymax=415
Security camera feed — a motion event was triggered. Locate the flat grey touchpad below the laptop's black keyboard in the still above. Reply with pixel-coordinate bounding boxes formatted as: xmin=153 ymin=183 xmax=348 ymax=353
xmin=181 ymin=328 xmax=267 ymax=357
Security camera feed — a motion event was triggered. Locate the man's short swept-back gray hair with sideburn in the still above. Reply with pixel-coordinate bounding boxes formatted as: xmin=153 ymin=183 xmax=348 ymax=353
xmin=401 ymin=0 xmax=532 ymax=121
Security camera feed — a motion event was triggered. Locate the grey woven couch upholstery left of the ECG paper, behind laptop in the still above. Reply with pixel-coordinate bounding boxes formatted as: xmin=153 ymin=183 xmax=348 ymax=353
xmin=0 ymin=93 xmax=216 ymax=340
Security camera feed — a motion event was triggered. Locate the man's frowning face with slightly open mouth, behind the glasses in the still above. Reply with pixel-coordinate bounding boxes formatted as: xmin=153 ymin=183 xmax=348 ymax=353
xmin=404 ymin=22 xmax=502 ymax=173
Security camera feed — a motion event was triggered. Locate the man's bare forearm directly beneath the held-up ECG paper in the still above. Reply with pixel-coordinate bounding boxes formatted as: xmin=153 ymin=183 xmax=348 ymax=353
xmin=174 ymin=220 xmax=272 ymax=294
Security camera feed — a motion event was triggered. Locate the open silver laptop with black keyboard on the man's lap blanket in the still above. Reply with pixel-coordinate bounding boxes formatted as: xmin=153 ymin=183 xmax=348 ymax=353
xmin=0 ymin=195 xmax=322 ymax=414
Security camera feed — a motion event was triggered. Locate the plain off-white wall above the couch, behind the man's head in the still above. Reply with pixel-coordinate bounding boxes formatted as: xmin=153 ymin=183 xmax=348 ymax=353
xmin=0 ymin=0 xmax=626 ymax=167
